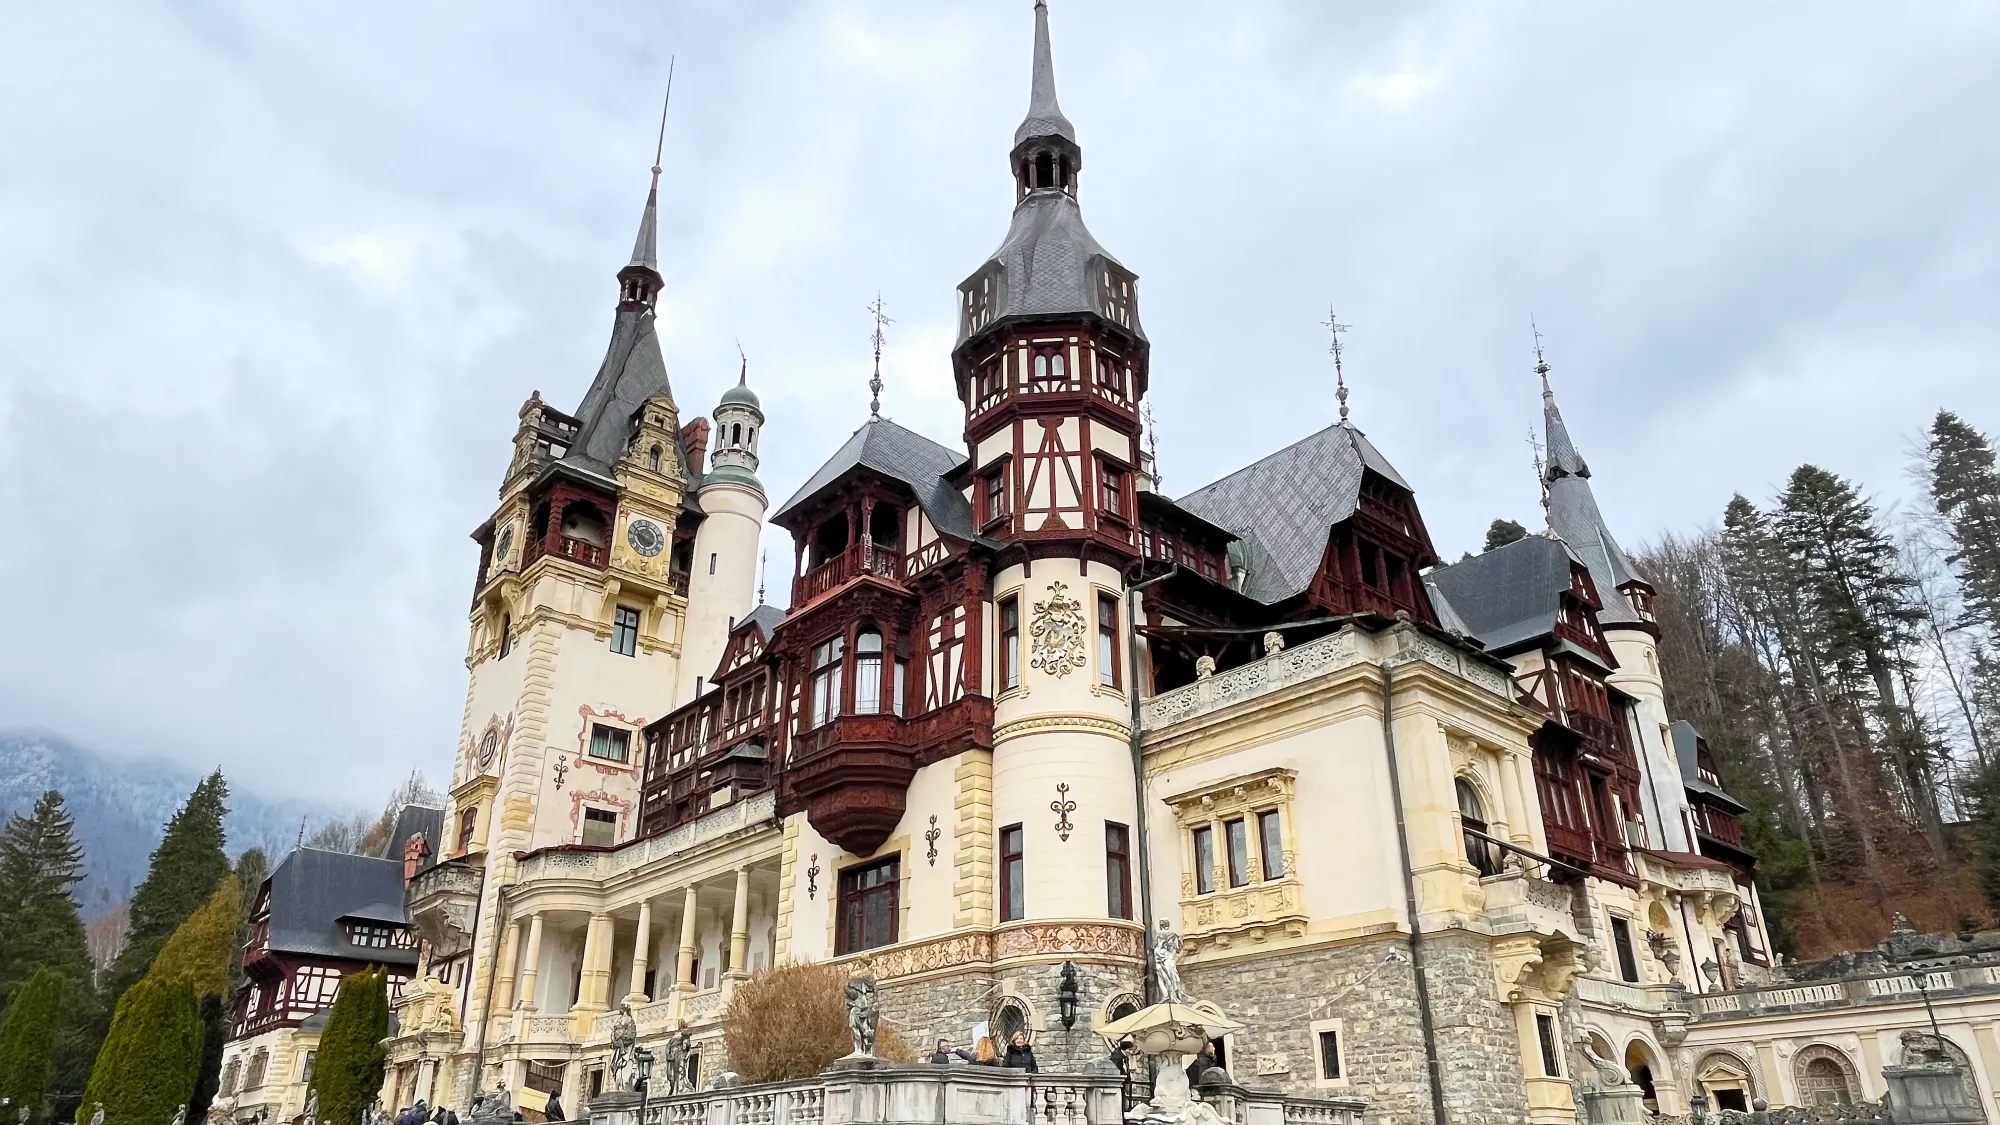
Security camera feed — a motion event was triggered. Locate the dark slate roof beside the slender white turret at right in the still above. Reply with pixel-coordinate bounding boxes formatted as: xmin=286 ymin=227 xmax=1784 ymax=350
xmin=1424 ymin=534 xmax=1572 ymax=653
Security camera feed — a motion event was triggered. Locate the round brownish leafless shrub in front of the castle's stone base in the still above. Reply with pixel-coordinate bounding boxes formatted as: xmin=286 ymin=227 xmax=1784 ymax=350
xmin=722 ymin=963 xmax=916 ymax=1083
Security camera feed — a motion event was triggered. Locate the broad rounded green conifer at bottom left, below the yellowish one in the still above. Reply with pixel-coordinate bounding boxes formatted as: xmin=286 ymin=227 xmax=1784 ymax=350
xmin=76 ymin=979 xmax=202 ymax=1125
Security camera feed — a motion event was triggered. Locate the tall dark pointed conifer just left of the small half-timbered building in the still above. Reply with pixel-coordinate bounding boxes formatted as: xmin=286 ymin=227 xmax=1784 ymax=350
xmin=110 ymin=771 xmax=230 ymax=999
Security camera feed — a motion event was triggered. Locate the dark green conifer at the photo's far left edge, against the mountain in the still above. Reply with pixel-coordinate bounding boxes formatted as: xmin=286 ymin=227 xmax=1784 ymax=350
xmin=0 ymin=789 xmax=90 ymax=995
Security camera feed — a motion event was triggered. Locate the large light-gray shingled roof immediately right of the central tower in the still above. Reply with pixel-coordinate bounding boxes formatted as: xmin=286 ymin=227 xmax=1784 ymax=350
xmin=1174 ymin=424 xmax=1410 ymax=605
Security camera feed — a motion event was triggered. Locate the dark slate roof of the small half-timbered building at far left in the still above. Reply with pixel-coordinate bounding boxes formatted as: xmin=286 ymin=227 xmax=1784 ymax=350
xmin=268 ymin=847 xmax=416 ymax=965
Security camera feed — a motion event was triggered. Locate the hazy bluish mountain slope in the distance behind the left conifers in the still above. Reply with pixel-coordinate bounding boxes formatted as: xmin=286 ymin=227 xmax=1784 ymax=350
xmin=0 ymin=731 xmax=342 ymax=917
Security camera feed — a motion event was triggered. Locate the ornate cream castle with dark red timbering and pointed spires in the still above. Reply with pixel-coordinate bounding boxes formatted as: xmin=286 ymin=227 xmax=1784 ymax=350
xmin=384 ymin=4 xmax=1992 ymax=1123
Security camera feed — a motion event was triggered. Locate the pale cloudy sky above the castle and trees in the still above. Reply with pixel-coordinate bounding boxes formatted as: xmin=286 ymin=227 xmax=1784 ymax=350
xmin=0 ymin=0 xmax=2000 ymax=805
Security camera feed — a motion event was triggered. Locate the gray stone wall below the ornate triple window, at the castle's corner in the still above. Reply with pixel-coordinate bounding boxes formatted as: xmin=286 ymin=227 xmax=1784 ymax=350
xmin=1182 ymin=935 xmax=1528 ymax=1125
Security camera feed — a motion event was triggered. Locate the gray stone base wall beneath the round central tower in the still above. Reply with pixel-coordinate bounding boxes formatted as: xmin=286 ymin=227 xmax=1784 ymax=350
xmin=882 ymin=961 xmax=1144 ymax=1071
